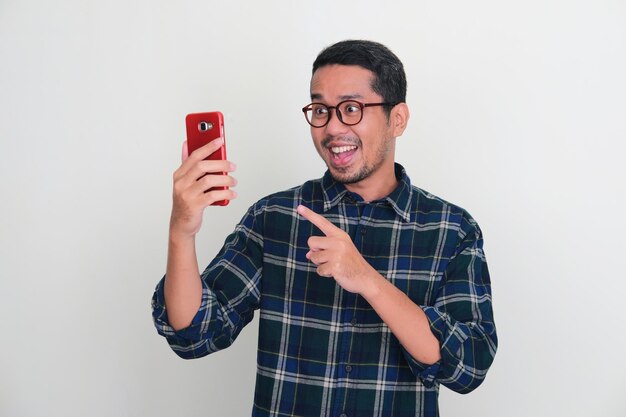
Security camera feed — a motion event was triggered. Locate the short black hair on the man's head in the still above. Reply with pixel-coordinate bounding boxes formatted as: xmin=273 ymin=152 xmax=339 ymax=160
xmin=313 ymin=40 xmax=406 ymax=114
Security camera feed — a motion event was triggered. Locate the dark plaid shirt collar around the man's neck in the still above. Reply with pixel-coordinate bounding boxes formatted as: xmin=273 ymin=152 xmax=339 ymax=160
xmin=322 ymin=163 xmax=413 ymax=222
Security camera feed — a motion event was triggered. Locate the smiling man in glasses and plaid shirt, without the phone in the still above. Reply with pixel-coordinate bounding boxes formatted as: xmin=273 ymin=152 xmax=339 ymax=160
xmin=153 ymin=41 xmax=497 ymax=417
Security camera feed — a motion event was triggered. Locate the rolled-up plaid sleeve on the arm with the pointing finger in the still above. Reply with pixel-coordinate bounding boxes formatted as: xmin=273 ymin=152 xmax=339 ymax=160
xmin=404 ymin=214 xmax=498 ymax=394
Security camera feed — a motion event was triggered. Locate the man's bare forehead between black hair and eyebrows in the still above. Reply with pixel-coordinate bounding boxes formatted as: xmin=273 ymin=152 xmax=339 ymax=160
xmin=311 ymin=65 xmax=378 ymax=100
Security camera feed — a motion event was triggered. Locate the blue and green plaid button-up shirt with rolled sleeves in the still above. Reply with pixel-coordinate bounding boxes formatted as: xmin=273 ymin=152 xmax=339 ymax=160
xmin=152 ymin=165 xmax=497 ymax=417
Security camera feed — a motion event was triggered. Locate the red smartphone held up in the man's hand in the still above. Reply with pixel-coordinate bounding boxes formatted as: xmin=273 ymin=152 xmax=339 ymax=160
xmin=185 ymin=111 xmax=228 ymax=206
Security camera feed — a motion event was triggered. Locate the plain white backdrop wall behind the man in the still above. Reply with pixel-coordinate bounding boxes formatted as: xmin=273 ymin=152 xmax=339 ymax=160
xmin=0 ymin=0 xmax=626 ymax=417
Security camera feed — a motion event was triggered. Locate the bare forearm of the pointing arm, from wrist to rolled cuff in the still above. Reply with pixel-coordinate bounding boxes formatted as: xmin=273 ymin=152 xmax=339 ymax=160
xmin=363 ymin=271 xmax=441 ymax=365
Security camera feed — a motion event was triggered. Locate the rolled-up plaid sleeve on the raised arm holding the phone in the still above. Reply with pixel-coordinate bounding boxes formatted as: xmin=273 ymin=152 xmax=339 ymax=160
xmin=152 ymin=202 xmax=263 ymax=359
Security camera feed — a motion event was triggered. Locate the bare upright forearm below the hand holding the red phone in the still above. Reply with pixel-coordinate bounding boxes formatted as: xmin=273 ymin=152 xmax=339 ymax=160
xmin=164 ymin=233 xmax=202 ymax=330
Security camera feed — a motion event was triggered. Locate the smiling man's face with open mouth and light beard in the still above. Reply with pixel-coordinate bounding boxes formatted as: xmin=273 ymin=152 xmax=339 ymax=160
xmin=311 ymin=65 xmax=394 ymax=184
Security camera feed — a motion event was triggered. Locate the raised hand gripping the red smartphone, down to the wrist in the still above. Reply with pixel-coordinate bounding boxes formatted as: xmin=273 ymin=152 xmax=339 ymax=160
xmin=170 ymin=138 xmax=237 ymax=238
